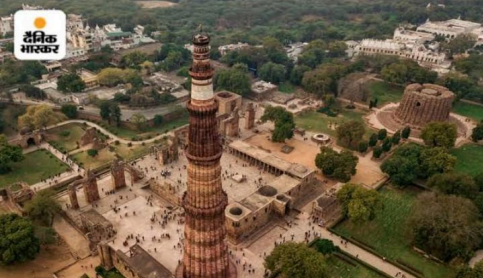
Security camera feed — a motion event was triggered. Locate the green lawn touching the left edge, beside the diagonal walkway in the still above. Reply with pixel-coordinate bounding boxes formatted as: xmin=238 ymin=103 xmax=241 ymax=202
xmin=0 ymin=150 xmax=69 ymax=188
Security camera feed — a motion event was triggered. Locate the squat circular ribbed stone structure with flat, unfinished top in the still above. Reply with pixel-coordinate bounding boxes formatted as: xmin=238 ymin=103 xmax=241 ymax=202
xmin=393 ymin=84 xmax=455 ymax=129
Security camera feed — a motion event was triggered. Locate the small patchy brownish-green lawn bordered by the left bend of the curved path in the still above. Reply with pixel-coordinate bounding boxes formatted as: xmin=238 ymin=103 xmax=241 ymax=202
xmin=49 ymin=123 xmax=85 ymax=152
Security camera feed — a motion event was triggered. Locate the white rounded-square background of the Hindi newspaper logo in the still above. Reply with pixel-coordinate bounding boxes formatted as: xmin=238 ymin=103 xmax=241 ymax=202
xmin=14 ymin=10 xmax=66 ymax=60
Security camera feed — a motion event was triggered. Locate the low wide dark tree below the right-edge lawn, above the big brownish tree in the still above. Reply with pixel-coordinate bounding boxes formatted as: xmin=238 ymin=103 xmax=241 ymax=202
xmin=427 ymin=172 xmax=479 ymax=198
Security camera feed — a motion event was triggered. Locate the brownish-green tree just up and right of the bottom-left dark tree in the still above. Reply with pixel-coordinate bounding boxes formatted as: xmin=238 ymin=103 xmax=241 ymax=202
xmin=25 ymin=190 xmax=61 ymax=227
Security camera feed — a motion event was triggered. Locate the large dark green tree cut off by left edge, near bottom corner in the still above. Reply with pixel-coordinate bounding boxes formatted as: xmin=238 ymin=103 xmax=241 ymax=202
xmin=0 ymin=214 xmax=40 ymax=265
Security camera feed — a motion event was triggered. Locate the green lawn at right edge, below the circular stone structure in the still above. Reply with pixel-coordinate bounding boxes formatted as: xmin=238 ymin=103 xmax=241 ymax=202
xmin=451 ymin=144 xmax=483 ymax=176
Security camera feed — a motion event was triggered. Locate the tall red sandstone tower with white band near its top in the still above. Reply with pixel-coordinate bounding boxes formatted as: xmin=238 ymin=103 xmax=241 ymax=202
xmin=176 ymin=33 xmax=236 ymax=278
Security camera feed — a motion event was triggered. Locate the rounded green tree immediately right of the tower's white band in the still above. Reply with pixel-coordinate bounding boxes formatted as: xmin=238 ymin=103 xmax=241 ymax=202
xmin=214 ymin=69 xmax=251 ymax=96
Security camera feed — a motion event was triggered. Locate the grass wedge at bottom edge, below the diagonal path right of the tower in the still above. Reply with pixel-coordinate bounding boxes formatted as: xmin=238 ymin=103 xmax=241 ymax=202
xmin=327 ymin=256 xmax=384 ymax=278
